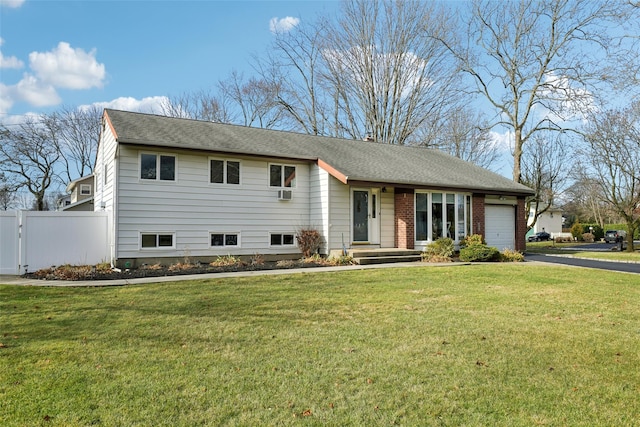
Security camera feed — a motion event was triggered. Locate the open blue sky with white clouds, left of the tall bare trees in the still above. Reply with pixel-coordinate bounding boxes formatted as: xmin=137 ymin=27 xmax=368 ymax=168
xmin=0 ymin=0 xmax=339 ymax=123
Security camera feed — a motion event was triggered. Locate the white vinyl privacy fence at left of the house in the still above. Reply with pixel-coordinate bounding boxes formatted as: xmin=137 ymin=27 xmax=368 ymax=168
xmin=0 ymin=211 xmax=111 ymax=275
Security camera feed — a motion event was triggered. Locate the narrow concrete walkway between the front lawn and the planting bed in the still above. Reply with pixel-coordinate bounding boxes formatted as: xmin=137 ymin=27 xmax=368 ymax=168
xmin=0 ymin=261 xmax=469 ymax=287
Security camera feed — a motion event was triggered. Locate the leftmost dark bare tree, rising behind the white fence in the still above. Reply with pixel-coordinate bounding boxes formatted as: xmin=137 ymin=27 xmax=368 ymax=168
xmin=0 ymin=115 xmax=61 ymax=210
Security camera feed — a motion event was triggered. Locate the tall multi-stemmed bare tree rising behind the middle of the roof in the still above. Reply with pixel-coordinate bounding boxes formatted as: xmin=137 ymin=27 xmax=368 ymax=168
xmin=323 ymin=0 xmax=456 ymax=145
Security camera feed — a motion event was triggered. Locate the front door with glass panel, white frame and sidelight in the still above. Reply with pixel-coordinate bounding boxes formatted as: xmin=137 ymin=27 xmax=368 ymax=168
xmin=351 ymin=189 xmax=380 ymax=244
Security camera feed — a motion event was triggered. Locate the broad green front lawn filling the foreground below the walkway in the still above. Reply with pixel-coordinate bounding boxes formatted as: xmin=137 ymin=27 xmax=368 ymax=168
xmin=0 ymin=264 xmax=640 ymax=426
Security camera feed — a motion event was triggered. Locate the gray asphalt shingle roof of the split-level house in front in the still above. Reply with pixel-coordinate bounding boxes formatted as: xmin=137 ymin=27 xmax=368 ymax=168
xmin=106 ymin=109 xmax=533 ymax=195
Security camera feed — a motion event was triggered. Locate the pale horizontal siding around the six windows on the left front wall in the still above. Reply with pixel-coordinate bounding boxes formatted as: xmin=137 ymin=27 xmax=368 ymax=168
xmin=118 ymin=145 xmax=310 ymax=258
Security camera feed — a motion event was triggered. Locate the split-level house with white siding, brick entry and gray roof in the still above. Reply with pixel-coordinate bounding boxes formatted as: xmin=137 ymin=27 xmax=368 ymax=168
xmin=94 ymin=109 xmax=533 ymax=267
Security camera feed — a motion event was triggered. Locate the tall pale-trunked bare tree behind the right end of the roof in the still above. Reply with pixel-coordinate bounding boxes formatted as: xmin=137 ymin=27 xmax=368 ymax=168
xmin=444 ymin=0 xmax=637 ymax=182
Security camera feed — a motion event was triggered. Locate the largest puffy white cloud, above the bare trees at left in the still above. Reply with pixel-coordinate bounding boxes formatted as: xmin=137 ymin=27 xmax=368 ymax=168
xmin=29 ymin=42 xmax=106 ymax=89
